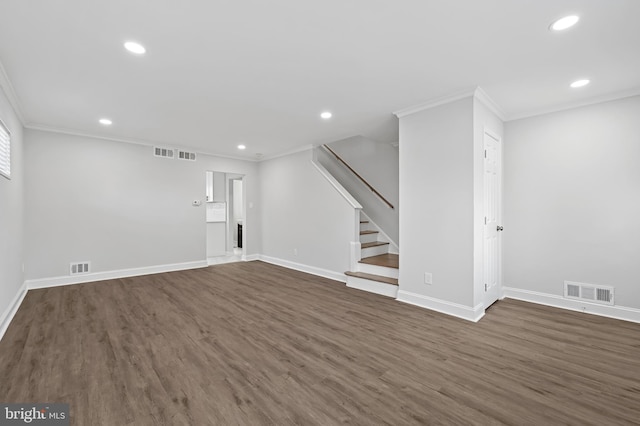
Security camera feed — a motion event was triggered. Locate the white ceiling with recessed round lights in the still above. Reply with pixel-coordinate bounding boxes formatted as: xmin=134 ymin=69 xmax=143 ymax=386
xmin=0 ymin=0 xmax=640 ymax=159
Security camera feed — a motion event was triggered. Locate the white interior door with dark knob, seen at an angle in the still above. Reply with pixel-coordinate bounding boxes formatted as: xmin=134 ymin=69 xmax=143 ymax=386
xmin=484 ymin=132 xmax=502 ymax=308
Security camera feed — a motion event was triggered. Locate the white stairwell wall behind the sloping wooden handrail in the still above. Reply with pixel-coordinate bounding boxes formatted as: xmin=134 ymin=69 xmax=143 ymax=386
xmin=328 ymin=136 xmax=400 ymax=244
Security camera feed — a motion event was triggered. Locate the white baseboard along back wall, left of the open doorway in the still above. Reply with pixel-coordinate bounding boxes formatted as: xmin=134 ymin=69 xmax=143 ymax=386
xmin=25 ymin=260 xmax=208 ymax=290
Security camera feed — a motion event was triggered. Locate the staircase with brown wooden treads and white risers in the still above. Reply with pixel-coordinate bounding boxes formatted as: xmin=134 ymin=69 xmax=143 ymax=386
xmin=345 ymin=213 xmax=399 ymax=298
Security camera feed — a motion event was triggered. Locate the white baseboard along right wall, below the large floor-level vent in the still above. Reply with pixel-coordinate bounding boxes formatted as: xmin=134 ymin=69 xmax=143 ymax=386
xmin=502 ymin=287 xmax=640 ymax=323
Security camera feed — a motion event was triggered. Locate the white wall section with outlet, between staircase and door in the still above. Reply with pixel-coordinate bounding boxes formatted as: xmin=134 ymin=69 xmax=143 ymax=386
xmin=398 ymin=96 xmax=474 ymax=313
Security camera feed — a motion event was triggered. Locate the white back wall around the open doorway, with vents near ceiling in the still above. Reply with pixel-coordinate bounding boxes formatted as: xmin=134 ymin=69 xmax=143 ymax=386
xmin=25 ymin=130 xmax=260 ymax=280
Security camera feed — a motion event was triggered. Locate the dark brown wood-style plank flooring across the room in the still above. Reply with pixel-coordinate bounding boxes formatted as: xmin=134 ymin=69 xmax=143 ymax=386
xmin=0 ymin=262 xmax=640 ymax=425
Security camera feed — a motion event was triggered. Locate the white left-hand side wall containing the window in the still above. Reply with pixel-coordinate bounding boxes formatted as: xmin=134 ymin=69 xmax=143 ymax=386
xmin=0 ymin=89 xmax=24 ymax=337
